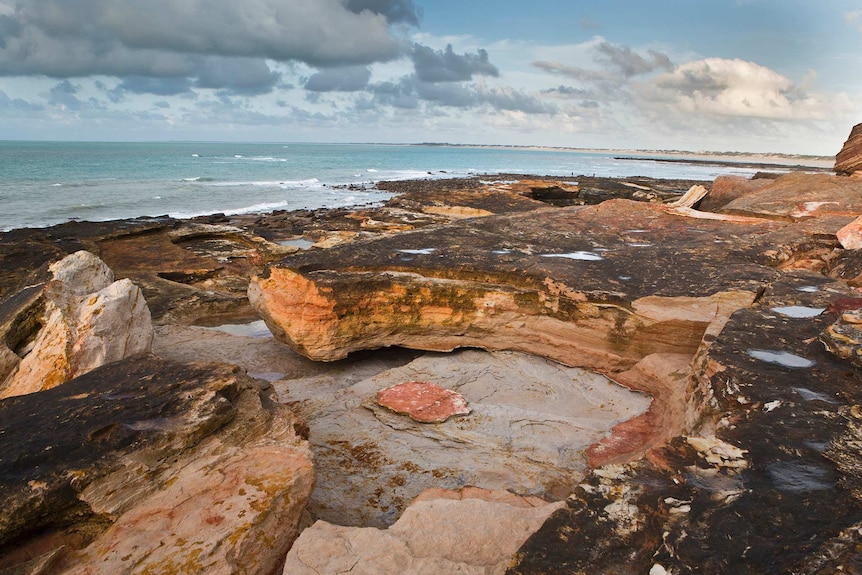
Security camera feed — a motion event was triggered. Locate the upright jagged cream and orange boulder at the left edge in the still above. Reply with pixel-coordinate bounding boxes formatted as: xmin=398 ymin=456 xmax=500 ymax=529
xmin=0 ymin=251 xmax=153 ymax=398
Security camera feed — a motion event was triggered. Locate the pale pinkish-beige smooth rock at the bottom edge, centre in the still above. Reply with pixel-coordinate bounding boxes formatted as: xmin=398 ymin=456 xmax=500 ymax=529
xmin=284 ymin=489 xmax=564 ymax=575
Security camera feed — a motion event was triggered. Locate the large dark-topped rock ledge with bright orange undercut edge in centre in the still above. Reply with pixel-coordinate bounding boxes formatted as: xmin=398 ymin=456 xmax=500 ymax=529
xmin=249 ymin=200 xmax=780 ymax=371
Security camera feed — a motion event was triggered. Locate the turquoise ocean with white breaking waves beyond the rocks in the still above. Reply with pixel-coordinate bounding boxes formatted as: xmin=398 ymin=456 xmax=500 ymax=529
xmin=0 ymin=141 xmax=768 ymax=231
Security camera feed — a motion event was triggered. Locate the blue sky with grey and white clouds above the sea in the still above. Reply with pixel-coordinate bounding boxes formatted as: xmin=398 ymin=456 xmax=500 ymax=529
xmin=0 ymin=0 xmax=862 ymax=156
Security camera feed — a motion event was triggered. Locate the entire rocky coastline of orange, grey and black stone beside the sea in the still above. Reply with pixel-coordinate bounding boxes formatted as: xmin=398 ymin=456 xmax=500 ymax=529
xmin=0 ymin=125 xmax=862 ymax=575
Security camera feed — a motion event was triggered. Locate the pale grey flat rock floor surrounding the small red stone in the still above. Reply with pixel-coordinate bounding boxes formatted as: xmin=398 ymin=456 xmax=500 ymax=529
xmin=273 ymin=350 xmax=650 ymax=527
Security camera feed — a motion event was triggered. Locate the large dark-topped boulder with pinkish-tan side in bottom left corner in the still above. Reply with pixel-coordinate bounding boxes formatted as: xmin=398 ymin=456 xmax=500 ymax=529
xmin=0 ymin=355 xmax=314 ymax=575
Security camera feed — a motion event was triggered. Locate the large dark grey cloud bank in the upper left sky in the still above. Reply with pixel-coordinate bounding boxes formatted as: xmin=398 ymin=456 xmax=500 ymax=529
xmin=0 ymin=0 xmax=418 ymax=83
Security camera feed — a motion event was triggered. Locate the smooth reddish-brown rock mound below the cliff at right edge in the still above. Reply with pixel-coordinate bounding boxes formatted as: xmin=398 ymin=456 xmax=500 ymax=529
xmin=721 ymin=172 xmax=862 ymax=221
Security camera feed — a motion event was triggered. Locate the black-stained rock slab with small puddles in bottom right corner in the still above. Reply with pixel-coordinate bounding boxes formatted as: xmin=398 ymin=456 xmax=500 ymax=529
xmin=509 ymin=274 xmax=862 ymax=575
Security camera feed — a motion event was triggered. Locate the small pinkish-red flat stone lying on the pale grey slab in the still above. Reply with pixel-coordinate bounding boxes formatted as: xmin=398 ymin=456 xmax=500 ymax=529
xmin=377 ymin=381 xmax=471 ymax=423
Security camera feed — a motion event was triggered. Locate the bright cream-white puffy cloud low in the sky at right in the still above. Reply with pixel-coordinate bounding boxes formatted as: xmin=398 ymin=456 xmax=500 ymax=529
xmin=639 ymin=58 xmax=828 ymax=121
